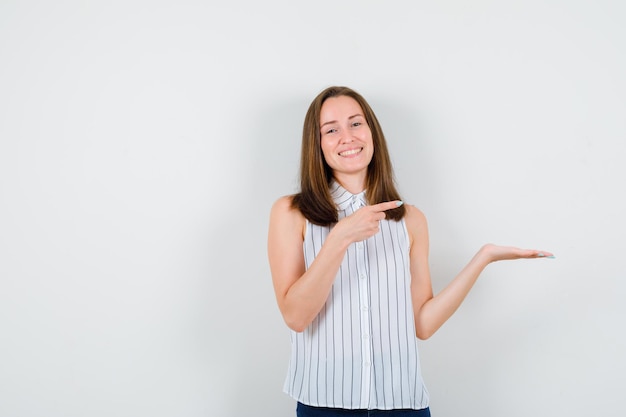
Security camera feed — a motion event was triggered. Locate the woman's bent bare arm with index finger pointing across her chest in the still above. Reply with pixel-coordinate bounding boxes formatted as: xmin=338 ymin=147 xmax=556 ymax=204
xmin=267 ymin=197 xmax=401 ymax=332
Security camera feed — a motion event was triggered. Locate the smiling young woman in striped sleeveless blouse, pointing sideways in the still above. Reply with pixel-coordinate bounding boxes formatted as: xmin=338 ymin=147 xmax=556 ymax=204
xmin=268 ymin=87 xmax=552 ymax=417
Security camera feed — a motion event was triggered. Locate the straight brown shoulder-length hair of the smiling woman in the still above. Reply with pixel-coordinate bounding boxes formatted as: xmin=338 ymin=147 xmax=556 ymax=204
xmin=292 ymin=87 xmax=406 ymax=226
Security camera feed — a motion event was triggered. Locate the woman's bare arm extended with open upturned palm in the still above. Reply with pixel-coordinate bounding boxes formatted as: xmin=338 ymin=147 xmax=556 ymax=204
xmin=405 ymin=205 xmax=552 ymax=339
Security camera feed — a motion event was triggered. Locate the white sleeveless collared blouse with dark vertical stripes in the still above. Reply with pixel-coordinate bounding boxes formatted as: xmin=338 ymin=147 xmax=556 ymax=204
xmin=285 ymin=182 xmax=428 ymax=410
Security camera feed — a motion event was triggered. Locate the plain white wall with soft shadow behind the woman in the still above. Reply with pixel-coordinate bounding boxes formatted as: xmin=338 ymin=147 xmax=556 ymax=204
xmin=0 ymin=0 xmax=626 ymax=417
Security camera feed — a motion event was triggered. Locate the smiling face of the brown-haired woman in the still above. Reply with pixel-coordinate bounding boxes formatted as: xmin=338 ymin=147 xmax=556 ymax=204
xmin=320 ymin=96 xmax=374 ymax=182
